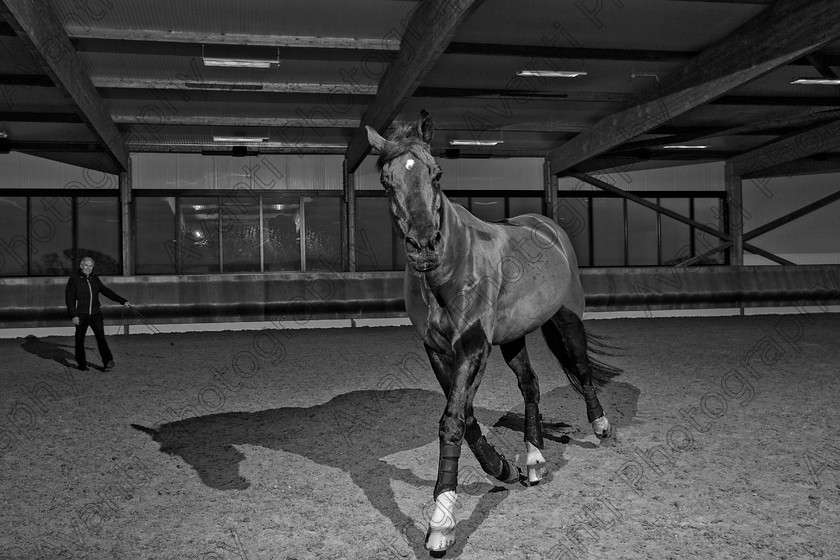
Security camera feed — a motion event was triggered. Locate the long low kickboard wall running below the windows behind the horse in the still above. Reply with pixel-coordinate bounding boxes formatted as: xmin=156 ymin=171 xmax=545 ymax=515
xmin=0 ymin=266 xmax=840 ymax=328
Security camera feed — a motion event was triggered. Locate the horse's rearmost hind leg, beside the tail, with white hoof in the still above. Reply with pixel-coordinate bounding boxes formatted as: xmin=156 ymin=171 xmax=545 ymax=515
xmin=542 ymin=307 xmax=613 ymax=438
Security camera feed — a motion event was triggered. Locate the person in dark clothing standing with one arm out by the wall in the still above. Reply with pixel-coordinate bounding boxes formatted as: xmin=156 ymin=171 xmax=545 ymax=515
xmin=65 ymin=257 xmax=128 ymax=371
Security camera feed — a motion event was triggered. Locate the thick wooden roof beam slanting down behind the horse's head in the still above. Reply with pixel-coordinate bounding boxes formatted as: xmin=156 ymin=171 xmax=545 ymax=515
xmin=347 ymin=0 xmax=483 ymax=173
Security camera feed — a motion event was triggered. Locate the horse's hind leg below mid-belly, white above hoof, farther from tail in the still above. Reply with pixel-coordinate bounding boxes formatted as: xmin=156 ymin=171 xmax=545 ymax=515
xmin=499 ymin=337 xmax=545 ymax=484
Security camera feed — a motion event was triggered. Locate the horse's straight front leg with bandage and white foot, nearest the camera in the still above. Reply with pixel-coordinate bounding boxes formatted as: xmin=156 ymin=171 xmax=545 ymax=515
xmin=426 ymin=324 xmax=491 ymax=552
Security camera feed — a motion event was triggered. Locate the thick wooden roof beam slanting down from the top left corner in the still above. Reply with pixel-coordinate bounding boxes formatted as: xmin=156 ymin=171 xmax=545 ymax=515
xmin=0 ymin=0 xmax=128 ymax=173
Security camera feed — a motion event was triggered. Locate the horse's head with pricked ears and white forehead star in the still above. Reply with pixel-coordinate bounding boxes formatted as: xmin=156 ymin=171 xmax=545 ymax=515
xmin=366 ymin=111 xmax=443 ymax=272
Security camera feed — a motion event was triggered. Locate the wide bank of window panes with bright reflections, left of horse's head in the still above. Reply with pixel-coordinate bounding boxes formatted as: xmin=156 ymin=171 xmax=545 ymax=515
xmin=134 ymin=189 xmax=343 ymax=274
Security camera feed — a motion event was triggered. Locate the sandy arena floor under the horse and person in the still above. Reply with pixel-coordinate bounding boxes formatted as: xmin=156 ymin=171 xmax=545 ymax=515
xmin=0 ymin=314 xmax=840 ymax=560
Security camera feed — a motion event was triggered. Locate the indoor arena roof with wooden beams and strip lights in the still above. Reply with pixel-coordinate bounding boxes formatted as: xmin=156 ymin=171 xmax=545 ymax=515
xmin=0 ymin=0 xmax=840 ymax=177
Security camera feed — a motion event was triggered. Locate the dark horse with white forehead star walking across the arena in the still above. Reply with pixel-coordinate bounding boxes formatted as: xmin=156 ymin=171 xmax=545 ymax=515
xmin=367 ymin=111 xmax=619 ymax=553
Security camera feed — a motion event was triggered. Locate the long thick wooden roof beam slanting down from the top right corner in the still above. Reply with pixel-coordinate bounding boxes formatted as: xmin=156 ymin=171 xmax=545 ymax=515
xmin=549 ymin=0 xmax=840 ymax=173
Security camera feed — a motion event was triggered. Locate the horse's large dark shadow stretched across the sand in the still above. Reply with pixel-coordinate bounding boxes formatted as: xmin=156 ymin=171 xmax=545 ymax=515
xmin=133 ymin=383 xmax=638 ymax=558
